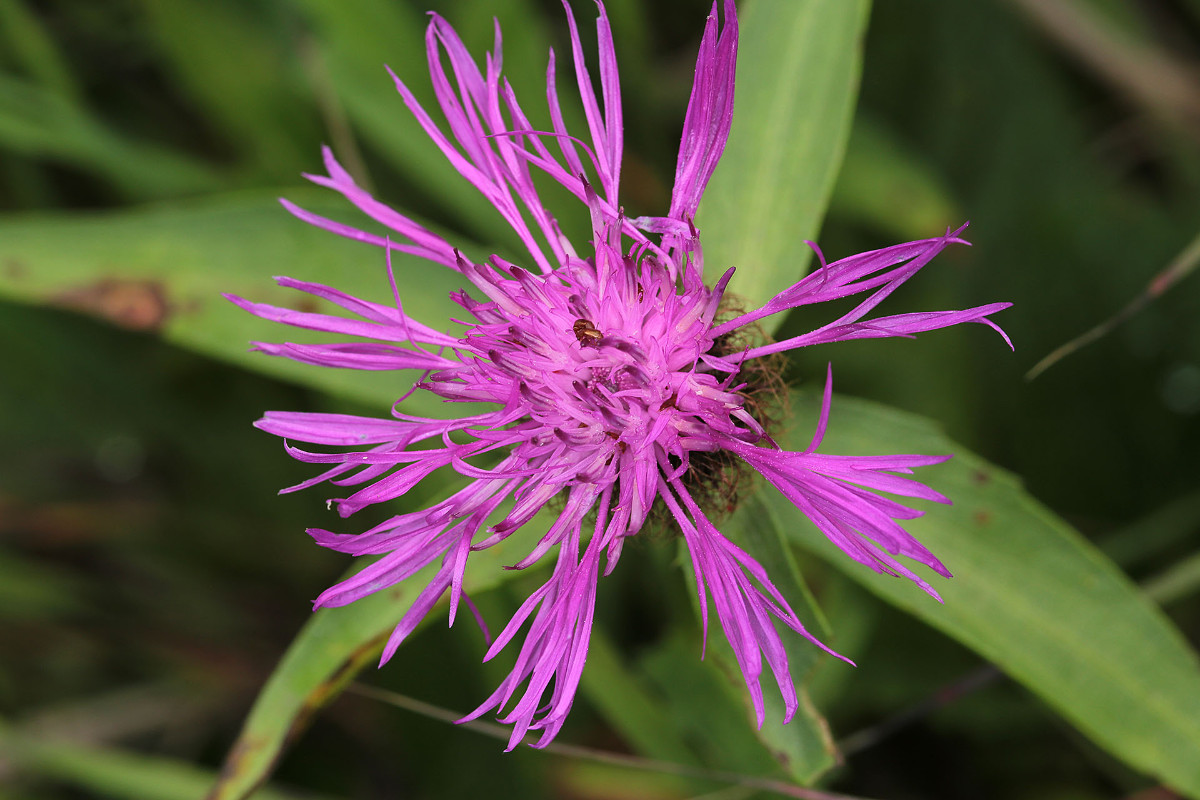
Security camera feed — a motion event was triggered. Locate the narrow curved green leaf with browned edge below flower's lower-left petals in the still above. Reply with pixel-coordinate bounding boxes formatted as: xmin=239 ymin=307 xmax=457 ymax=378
xmin=206 ymin=522 xmax=548 ymax=800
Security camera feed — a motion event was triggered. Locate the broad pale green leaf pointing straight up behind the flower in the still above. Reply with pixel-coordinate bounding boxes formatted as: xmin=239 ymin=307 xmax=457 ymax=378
xmin=697 ymin=0 xmax=870 ymax=324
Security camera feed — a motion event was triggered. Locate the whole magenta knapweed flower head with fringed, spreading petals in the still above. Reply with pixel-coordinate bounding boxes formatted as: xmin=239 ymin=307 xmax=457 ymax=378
xmin=232 ymin=0 xmax=1008 ymax=748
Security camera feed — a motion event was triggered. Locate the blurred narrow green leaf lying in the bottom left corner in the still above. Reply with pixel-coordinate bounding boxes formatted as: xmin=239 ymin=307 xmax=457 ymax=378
xmin=0 ymin=723 xmax=328 ymax=800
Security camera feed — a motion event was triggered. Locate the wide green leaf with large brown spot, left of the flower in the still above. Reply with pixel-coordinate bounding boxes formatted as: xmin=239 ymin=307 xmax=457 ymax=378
xmin=0 ymin=188 xmax=469 ymax=415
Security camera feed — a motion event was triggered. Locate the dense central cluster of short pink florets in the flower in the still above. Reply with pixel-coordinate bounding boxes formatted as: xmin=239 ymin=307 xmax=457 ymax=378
xmin=422 ymin=247 xmax=778 ymax=513
